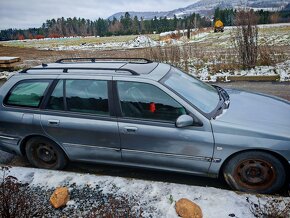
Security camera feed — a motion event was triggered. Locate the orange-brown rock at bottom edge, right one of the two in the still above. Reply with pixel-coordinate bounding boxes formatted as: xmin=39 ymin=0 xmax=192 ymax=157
xmin=175 ymin=198 xmax=202 ymax=218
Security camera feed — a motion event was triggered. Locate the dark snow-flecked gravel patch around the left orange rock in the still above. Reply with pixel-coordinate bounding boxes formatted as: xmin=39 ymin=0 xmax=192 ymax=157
xmin=0 ymin=180 xmax=142 ymax=218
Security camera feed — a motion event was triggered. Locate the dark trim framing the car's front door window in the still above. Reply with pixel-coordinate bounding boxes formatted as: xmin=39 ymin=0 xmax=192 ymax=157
xmin=113 ymin=80 xmax=187 ymax=126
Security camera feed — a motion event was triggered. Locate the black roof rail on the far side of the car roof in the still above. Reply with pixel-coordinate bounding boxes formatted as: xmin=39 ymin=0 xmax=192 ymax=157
xmin=55 ymin=57 xmax=153 ymax=64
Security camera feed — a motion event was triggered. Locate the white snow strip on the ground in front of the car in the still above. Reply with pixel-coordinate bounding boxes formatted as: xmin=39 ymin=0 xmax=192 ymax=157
xmin=0 ymin=167 xmax=290 ymax=218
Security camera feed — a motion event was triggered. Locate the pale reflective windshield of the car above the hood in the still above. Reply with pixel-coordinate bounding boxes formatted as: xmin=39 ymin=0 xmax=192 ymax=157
xmin=163 ymin=67 xmax=220 ymax=114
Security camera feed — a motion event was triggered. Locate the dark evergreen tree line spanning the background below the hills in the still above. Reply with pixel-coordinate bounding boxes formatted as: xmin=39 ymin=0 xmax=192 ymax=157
xmin=0 ymin=8 xmax=290 ymax=41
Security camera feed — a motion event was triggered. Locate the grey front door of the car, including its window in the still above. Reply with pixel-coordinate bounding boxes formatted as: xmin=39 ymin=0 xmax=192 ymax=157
xmin=115 ymin=79 xmax=214 ymax=174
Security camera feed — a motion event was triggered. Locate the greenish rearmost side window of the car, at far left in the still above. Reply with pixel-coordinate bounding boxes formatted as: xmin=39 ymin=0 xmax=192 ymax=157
xmin=4 ymin=80 xmax=51 ymax=108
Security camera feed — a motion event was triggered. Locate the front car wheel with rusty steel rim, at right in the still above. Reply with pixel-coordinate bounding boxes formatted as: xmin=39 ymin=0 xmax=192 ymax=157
xmin=223 ymin=151 xmax=286 ymax=194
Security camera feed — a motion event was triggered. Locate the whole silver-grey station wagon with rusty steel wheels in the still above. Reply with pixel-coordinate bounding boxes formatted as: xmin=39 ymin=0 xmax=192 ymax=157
xmin=0 ymin=58 xmax=290 ymax=193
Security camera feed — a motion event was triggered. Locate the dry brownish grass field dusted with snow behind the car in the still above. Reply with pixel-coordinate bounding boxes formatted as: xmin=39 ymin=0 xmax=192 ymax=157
xmin=0 ymin=23 xmax=290 ymax=74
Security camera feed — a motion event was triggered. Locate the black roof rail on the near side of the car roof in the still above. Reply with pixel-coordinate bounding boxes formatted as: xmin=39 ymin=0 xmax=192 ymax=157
xmin=20 ymin=67 xmax=140 ymax=76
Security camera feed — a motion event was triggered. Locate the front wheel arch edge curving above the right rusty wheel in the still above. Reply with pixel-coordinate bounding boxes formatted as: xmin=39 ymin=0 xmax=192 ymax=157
xmin=218 ymin=149 xmax=290 ymax=181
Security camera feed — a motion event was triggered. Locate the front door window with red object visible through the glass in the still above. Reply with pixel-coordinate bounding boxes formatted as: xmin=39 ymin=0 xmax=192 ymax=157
xmin=117 ymin=81 xmax=186 ymax=122
